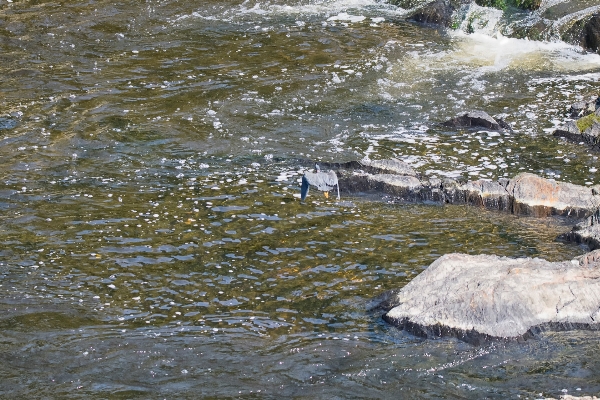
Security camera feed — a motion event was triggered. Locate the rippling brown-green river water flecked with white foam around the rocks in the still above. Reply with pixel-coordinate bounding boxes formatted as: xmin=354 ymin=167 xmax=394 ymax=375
xmin=0 ymin=0 xmax=600 ymax=399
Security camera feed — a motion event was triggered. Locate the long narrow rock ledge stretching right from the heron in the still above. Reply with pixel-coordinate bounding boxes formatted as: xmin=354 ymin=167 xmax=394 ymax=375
xmin=324 ymin=160 xmax=600 ymax=218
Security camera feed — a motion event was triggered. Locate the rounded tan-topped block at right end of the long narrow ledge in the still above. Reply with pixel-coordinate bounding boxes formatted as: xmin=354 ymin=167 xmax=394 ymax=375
xmin=506 ymin=173 xmax=600 ymax=218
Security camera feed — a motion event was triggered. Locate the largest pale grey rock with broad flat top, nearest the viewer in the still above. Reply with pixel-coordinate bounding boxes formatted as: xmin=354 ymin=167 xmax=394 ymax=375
xmin=384 ymin=254 xmax=600 ymax=344
